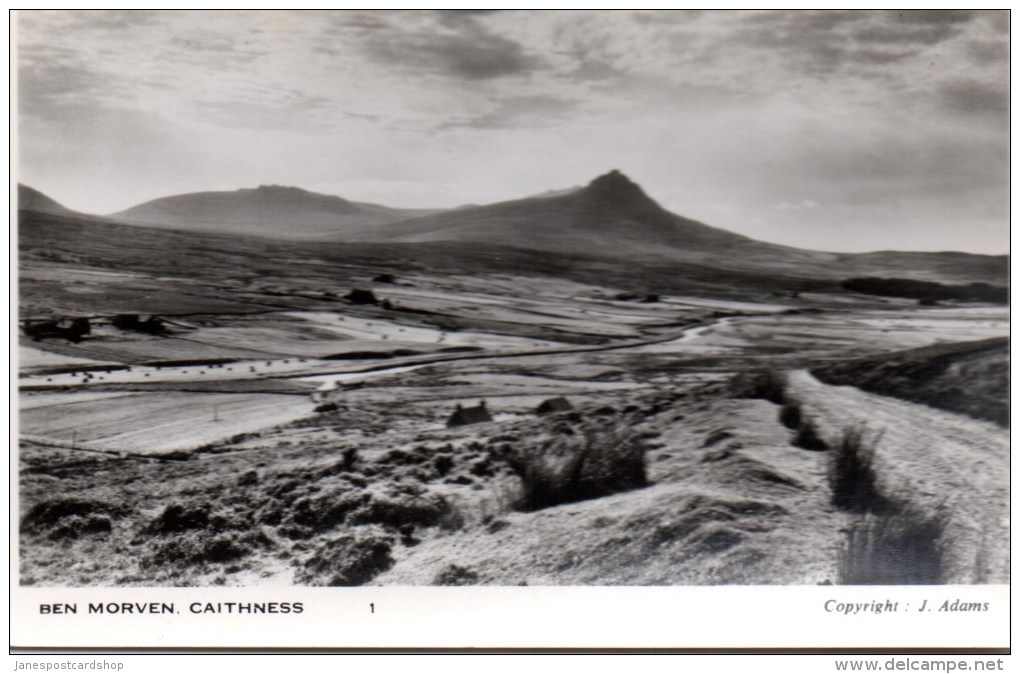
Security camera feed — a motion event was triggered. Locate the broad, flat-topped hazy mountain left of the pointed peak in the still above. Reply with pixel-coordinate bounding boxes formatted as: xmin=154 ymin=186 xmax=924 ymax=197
xmin=108 ymin=185 xmax=435 ymax=240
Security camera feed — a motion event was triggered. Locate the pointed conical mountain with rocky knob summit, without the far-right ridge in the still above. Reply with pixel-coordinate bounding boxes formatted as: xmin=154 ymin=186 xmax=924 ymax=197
xmin=354 ymin=170 xmax=834 ymax=264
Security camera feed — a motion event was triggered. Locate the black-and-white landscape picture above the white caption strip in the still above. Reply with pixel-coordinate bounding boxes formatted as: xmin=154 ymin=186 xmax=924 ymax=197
xmin=11 ymin=9 xmax=1010 ymax=652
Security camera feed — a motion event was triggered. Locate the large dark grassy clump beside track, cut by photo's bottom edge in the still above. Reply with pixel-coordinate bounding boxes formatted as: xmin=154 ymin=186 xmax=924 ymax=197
xmin=838 ymin=504 xmax=948 ymax=585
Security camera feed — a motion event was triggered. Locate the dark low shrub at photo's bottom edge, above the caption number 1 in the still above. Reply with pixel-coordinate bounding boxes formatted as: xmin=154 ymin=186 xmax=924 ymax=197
xmin=295 ymin=532 xmax=394 ymax=587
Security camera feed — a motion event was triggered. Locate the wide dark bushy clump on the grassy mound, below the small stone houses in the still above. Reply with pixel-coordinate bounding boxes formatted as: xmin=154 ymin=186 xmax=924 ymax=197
xmin=509 ymin=426 xmax=648 ymax=511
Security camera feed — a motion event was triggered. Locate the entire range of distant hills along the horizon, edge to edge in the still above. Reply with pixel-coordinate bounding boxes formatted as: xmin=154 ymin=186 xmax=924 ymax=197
xmin=18 ymin=170 xmax=1009 ymax=286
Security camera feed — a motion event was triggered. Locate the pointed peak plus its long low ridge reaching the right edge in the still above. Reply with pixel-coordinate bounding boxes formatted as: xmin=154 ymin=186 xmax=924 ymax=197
xmin=350 ymin=170 xmax=1008 ymax=284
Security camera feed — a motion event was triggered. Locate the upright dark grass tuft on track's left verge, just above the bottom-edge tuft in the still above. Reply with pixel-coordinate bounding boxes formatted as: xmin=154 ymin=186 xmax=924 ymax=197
xmin=828 ymin=426 xmax=885 ymax=513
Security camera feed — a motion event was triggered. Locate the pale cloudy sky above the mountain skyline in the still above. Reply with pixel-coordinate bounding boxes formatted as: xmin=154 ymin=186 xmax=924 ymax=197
xmin=16 ymin=10 xmax=1010 ymax=254
